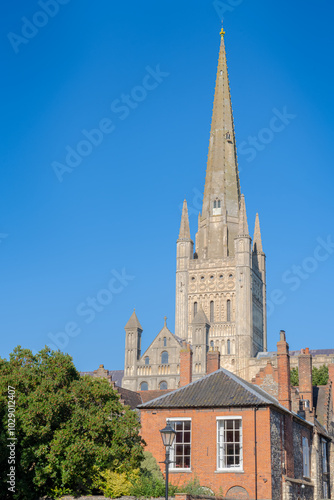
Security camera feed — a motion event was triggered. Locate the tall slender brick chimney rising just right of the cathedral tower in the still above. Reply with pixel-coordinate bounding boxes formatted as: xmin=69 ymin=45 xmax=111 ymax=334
xmin=277 ymin=330 xmax=291 ymax=411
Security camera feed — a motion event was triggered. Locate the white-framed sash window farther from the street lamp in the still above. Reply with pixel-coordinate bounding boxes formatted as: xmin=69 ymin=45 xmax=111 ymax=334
xmin=217 ymin=417 xmax=242 ymax=471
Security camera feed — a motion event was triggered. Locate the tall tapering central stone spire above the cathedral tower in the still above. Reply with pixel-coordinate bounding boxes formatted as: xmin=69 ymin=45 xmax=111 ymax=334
xmin=202 ymin=23 xmax=240 ymax=217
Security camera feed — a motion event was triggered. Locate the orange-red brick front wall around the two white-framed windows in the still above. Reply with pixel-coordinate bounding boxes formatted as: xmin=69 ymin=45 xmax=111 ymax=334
xmin=141 ymin=408 xmax=272 ymax=500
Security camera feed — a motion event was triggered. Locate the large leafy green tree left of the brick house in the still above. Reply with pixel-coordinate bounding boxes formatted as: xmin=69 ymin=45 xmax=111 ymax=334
xmin=0 ymin=347 xmax=143 ymax=500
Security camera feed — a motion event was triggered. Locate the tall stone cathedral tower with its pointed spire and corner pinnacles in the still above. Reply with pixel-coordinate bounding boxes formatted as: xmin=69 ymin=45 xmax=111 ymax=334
xmin=175 ymin=26 xmax=267 ymax=377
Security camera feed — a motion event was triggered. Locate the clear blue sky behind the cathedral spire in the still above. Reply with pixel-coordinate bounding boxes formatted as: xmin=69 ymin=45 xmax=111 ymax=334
xmin=0 ymin=0 xmax=334 ymax=370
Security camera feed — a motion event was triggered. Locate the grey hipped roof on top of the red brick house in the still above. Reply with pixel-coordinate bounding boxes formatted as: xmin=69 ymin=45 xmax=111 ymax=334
xmin=138 ymin=368 xmax=288 ymax=411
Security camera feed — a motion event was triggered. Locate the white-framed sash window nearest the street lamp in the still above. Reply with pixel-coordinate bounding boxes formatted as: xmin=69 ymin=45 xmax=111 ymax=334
xmin=167 ymin=418 xmax=191 ymax=472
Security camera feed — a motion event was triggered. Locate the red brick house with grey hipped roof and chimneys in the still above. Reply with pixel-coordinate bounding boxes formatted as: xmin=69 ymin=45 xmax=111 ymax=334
xmin=139 ymin=332 xmax=333 ymax=500
